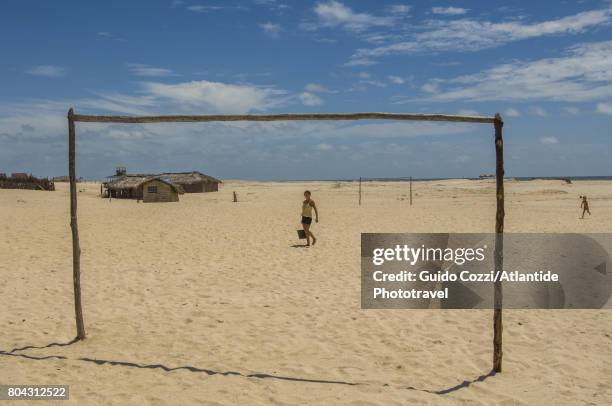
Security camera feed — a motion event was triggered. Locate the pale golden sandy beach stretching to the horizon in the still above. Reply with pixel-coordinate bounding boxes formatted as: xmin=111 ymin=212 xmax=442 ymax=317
xmin=0 ymin=180 xmax=612 ymax=405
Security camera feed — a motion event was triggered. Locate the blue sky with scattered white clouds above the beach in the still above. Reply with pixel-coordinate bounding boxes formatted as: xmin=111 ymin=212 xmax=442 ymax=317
xmin=0 ymin=0 xmax=612 ymax=179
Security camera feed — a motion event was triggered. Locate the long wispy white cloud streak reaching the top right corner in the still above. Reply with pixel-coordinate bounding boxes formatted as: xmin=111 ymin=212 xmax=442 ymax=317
xmin=347 ymin=8 xmax=612 ymax=66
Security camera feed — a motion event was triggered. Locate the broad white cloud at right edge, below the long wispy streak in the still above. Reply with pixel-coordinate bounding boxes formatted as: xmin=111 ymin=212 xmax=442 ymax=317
xmin=408 ymin=41 xmax=612 ymax=102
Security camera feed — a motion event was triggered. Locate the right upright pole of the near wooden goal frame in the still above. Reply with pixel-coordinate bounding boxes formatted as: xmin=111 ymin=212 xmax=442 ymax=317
xmin=493 ymin=113 xmax=505 ymax=372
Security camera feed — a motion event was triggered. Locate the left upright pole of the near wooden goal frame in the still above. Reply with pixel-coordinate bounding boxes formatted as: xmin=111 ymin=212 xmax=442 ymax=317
xmin=68 ymin=109 xmax=85 ymax=340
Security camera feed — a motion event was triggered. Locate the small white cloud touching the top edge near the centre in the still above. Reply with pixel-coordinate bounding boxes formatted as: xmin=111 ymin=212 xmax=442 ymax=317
xmin=314 ymin=0 xmax=393 ymax=32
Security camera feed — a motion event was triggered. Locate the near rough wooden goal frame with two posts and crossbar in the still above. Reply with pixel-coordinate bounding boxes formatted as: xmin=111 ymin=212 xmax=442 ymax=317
xmin=68 ymin=108 xmax=505 ymax=372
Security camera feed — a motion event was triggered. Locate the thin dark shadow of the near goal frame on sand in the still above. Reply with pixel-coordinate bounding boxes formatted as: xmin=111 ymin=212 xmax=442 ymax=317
xmin=0 ymin=338 xmax=495 ymax=395
